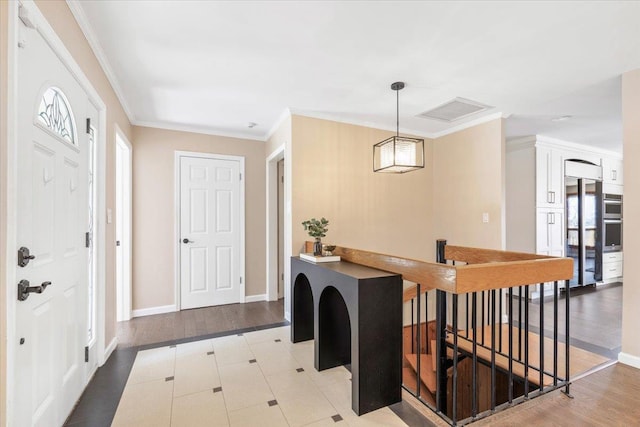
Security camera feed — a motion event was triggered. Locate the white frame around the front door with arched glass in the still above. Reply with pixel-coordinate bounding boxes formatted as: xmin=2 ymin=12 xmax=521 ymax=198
xmin=0 ymin=0 xmax=107 ymax=425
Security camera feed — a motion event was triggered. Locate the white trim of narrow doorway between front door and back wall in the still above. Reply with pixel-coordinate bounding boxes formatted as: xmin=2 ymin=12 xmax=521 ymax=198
xmin=115 ymin=125 xmax=133 ymax=320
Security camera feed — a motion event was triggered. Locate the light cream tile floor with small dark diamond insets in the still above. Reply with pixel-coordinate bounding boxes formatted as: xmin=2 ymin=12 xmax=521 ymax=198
xmin=112 ymin=326 xmax=406 ymax=427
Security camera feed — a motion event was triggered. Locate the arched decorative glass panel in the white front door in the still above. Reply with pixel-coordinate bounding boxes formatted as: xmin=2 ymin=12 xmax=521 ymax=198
xmin=37 ymin=86 xmax=76 ymax=145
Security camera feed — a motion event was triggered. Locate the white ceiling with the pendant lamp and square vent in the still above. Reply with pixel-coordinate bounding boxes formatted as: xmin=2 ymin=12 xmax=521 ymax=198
xmin=69 ymin=0 xmax=640 ymax=151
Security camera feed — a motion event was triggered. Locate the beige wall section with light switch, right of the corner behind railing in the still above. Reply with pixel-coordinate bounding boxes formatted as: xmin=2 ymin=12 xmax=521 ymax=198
xmin=433 ymin=119 xmax=505 ymax=249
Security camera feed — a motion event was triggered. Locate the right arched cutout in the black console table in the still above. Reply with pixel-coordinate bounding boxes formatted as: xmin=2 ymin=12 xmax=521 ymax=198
xmin=318 ymin=286 xmax=351 ymax=369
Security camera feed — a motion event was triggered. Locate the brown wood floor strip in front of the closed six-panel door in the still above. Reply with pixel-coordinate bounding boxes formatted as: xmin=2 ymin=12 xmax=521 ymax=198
xmin=118 ymin=300 xmax=284 ymax=348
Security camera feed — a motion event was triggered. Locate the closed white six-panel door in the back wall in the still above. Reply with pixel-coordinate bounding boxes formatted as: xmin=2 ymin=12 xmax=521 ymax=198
xmin=180 ymin=156 xmax=244 ymax=309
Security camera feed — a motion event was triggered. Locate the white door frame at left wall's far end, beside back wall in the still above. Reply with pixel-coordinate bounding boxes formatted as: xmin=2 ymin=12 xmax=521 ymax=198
xmin=115 ymin=125 xmax=133 ymax=321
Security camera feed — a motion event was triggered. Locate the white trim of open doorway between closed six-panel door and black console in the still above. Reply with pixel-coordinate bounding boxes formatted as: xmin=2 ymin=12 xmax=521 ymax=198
xmin=265 ymin=144 xmax=286 ymax=301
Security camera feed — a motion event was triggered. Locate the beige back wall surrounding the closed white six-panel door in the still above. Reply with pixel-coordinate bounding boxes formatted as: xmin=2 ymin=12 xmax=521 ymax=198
xmin=131 ymin=126 xmax=266 ymax=310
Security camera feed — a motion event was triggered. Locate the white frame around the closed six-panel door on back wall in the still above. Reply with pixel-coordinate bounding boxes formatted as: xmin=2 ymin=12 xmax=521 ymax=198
xmin=173 ymin=150 xmax=247 ymax=311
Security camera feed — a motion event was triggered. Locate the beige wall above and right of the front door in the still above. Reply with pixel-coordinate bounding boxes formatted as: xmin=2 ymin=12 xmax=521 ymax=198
xmin=36 ymin=0 xmax=131 ymax=346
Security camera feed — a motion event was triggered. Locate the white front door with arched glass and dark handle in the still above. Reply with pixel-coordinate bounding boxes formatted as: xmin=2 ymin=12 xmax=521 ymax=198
xmin=15 ymin=20 xmax=90 ymax=426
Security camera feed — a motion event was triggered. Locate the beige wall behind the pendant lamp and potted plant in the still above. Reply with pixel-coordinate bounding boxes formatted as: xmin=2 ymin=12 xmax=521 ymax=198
xmin=291 ymin=116 xmax=435 ymax=261
